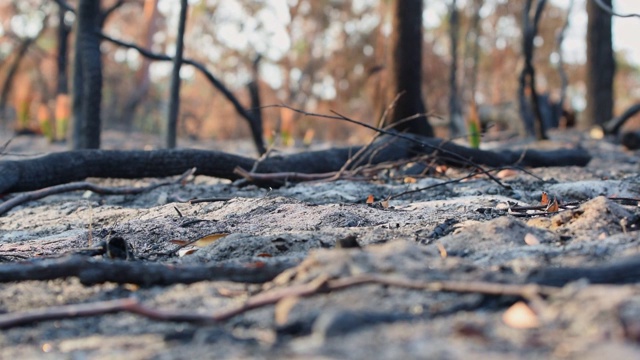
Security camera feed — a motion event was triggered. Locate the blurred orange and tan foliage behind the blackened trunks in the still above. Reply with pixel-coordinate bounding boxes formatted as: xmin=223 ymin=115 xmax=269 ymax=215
xmin=0 ymin=0 xmax=640 ymax=145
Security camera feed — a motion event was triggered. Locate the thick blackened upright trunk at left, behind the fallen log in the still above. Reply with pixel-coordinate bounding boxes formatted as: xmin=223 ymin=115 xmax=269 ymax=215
xmin=72 ymin=0 xmax=102 ymax=149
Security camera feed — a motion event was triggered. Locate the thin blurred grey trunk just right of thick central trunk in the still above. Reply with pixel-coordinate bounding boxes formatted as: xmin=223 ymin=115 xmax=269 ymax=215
xmin=449 ymin=0 xmax=465 ymax=138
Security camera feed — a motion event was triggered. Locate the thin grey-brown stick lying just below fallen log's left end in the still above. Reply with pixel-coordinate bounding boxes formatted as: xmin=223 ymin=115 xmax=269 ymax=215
xmin=0 ymin=168 xmax=196 ymax=215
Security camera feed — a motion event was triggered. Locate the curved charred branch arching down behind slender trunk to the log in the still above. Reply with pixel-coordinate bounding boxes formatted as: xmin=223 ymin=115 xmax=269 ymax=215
xmin=98 ymin=33 xmax=266 ymax=154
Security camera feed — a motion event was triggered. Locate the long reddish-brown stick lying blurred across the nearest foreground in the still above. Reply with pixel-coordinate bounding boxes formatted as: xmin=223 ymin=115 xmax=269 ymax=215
xmin=0 ymin=274 xmax=559 ymax=329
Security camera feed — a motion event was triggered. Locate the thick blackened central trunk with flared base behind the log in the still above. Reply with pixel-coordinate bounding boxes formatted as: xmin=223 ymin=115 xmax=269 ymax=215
xmin=391 ymin=0 xmax=433 ymax=136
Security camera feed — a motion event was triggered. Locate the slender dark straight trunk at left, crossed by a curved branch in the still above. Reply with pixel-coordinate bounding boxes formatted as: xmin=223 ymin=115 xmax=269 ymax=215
xmin=164 ymin=0 xmax=189 ymax=149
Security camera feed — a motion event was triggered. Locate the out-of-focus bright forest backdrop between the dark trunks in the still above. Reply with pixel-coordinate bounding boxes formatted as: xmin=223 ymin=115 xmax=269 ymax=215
xmin=0 ymin=0 xmax=640 ymax=149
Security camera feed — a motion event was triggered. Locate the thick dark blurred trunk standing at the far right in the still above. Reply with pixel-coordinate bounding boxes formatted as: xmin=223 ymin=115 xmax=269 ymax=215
xmin=584 ymin=0 xmax=616 ymax=126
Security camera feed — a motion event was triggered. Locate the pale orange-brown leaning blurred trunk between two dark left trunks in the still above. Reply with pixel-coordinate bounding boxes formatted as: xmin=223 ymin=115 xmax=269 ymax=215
xmin=120 ymin=0 xmax=159 ymax=129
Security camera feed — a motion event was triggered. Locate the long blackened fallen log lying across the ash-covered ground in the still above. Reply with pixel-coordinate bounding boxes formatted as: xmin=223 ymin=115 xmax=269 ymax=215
xmin=0 ymin=134 xmax=591 ymax=194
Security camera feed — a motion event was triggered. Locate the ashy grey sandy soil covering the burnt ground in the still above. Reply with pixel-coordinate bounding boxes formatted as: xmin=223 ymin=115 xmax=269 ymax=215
xmin=0 ymin=134 xmax=640 ymax=359
